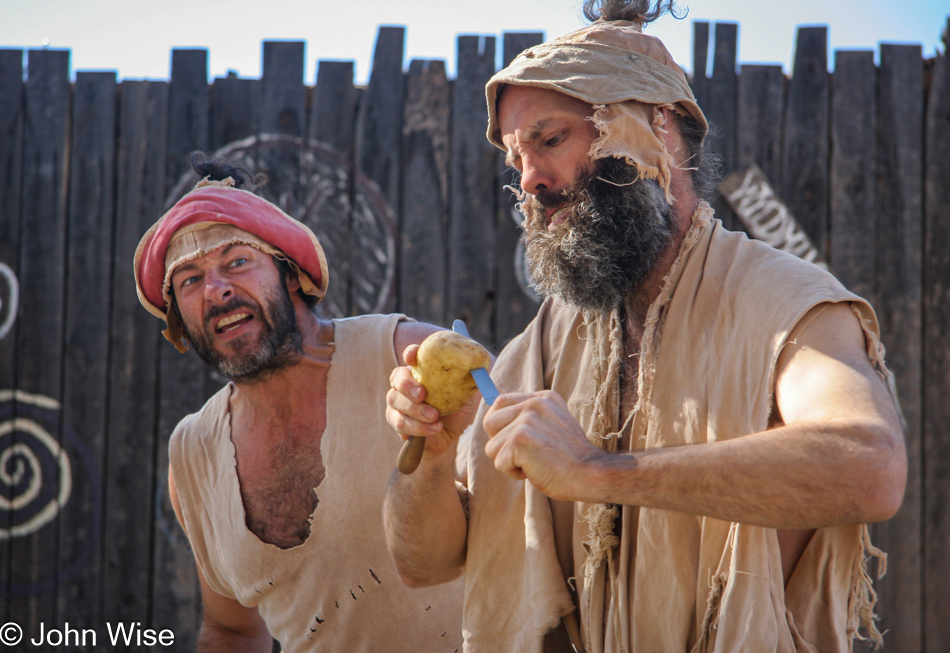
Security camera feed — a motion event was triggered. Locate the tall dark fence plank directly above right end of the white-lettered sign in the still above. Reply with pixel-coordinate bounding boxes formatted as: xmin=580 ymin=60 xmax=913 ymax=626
xmin=776 ymin=27 xmax=829 ymax=259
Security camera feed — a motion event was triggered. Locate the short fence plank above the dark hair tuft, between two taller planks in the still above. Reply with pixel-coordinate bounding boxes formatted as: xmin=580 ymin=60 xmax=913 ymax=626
xmin=211 ymin=73 xmax=261 ymax=151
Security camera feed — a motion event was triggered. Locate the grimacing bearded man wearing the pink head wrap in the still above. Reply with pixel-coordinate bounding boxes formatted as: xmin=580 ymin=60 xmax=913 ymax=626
xmin=135 ymin=162 xmax=462 ymax=653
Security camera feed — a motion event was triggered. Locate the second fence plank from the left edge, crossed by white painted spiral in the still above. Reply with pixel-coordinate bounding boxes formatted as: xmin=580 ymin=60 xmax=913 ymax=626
xmin=10 ymin=50 xmax=70 ymax=633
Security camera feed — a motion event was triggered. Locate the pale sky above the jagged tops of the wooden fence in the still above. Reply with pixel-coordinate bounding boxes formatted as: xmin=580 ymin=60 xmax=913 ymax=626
xmin=0 ymin=0 xmax=950 ymax=84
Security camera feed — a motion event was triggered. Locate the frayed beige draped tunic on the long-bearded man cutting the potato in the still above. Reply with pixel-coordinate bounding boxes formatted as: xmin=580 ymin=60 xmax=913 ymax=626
xmin=459 ymin=205 xmax=886 ymax=653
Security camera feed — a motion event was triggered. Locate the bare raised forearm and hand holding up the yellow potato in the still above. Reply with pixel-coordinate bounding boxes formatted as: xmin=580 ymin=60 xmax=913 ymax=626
xmin=383 ymin=344 xmax=479 ymax=587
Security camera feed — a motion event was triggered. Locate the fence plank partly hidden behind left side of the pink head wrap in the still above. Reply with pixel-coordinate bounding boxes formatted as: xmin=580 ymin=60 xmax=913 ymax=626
xmin=149 ymin=50 xmax=210 ymax=650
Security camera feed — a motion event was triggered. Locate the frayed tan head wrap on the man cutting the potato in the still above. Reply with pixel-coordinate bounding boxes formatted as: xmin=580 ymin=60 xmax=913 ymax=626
xmin=485 ymin=20 xmax=708 ymax=199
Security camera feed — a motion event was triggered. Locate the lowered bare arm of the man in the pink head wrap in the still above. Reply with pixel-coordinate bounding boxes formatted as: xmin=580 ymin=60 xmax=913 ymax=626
xmin=168 ymin=468 xmax=273 ymax=653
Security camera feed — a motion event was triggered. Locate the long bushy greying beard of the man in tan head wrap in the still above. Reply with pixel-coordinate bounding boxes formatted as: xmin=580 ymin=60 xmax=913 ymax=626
xmin=522 ymin=158 xmax=674 ymax=313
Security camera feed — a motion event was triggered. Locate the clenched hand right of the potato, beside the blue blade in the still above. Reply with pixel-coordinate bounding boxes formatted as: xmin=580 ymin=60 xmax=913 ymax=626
xmin=482 ymin=390 xmax=608 ymax=501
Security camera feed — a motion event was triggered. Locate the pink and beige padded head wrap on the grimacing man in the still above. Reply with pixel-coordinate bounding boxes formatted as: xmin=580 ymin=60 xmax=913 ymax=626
xmin=133 ymin=177 xmax=329 ymax=352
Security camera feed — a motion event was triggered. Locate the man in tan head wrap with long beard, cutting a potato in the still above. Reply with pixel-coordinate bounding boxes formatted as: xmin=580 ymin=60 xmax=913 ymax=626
xmin=385 ymin=0 xmax=906 ymax=653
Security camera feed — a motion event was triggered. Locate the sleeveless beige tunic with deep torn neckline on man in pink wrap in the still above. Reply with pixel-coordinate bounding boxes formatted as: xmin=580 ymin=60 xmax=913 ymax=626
xmin=169 ymin=315 xmax=462 ymax=653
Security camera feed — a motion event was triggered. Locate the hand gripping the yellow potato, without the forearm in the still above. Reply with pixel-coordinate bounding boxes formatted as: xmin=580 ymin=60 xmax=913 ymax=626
xmin=386 ymin=345 xmax=481 ymax=455
